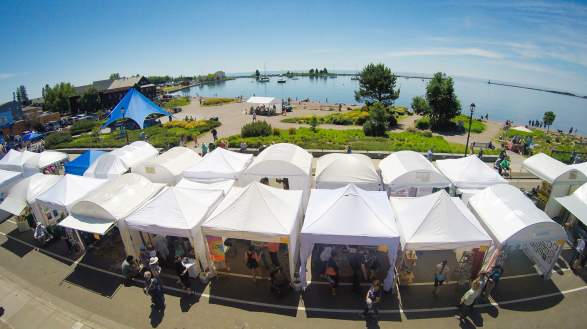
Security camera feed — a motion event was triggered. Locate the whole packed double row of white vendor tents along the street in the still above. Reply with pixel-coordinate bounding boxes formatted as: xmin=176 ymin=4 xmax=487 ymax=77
xmin=0 ymin=142 xmax=584 ymax=288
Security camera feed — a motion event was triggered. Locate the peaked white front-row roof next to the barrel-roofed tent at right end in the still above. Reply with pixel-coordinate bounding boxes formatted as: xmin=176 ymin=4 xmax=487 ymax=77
xmin=390 ymin=190 xmax=491 ymax=250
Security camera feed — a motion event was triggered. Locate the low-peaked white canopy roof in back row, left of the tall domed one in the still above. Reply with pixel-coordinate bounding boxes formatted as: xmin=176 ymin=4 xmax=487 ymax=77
xmin=183 ymin=147 xmax=253 ymax=182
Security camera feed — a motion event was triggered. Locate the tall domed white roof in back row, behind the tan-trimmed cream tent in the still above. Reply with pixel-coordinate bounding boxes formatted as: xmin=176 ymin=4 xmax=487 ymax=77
xmin=244 ymin=143 xmax=313 ymax=177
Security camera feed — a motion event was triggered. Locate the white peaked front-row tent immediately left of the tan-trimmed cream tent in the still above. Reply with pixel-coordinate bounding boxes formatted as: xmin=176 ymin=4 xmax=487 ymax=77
xmin=123 ymin=187 xmax=223 ymax=267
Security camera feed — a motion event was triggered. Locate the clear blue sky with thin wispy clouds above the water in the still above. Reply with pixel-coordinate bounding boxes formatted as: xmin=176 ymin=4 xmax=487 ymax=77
xmin=0 ymin=0 xmax=587 ymax=101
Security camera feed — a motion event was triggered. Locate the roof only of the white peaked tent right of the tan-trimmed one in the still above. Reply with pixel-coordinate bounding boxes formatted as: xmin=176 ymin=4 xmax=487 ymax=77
xmin=301 ymin=184 xmax=399 ymax=238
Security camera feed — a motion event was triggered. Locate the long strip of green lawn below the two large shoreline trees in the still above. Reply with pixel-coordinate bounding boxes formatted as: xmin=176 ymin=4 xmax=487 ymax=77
xmin=228 ymin=128 xmax=490 ymax=153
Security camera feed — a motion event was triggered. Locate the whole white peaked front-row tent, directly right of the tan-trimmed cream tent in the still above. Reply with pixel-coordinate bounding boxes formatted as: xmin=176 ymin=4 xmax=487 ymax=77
xmin=300 ymin=184 xmax=399 ymax=291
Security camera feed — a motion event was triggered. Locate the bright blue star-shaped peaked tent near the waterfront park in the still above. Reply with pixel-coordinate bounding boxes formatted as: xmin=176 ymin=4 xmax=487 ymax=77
xmin=104 ymin=88 xmax=171 ymax=129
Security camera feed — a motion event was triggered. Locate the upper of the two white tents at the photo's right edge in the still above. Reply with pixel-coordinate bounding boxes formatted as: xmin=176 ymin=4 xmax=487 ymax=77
xmin=522 ymin=153 xmax=587 ymax=217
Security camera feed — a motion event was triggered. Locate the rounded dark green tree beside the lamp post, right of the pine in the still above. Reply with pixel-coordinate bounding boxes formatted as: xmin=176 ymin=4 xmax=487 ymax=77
xmin=426 ymin=72 xmax=461 ymax=129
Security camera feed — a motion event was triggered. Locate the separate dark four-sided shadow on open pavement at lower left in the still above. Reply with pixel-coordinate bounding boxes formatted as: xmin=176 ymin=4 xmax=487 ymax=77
xmin=64 ymin=266 xmax=122 ymax=298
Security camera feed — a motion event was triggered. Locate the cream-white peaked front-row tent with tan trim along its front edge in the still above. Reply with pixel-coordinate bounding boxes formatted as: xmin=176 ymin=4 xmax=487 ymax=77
xmin=202 ymin=182 xmax=303 ymax=276
